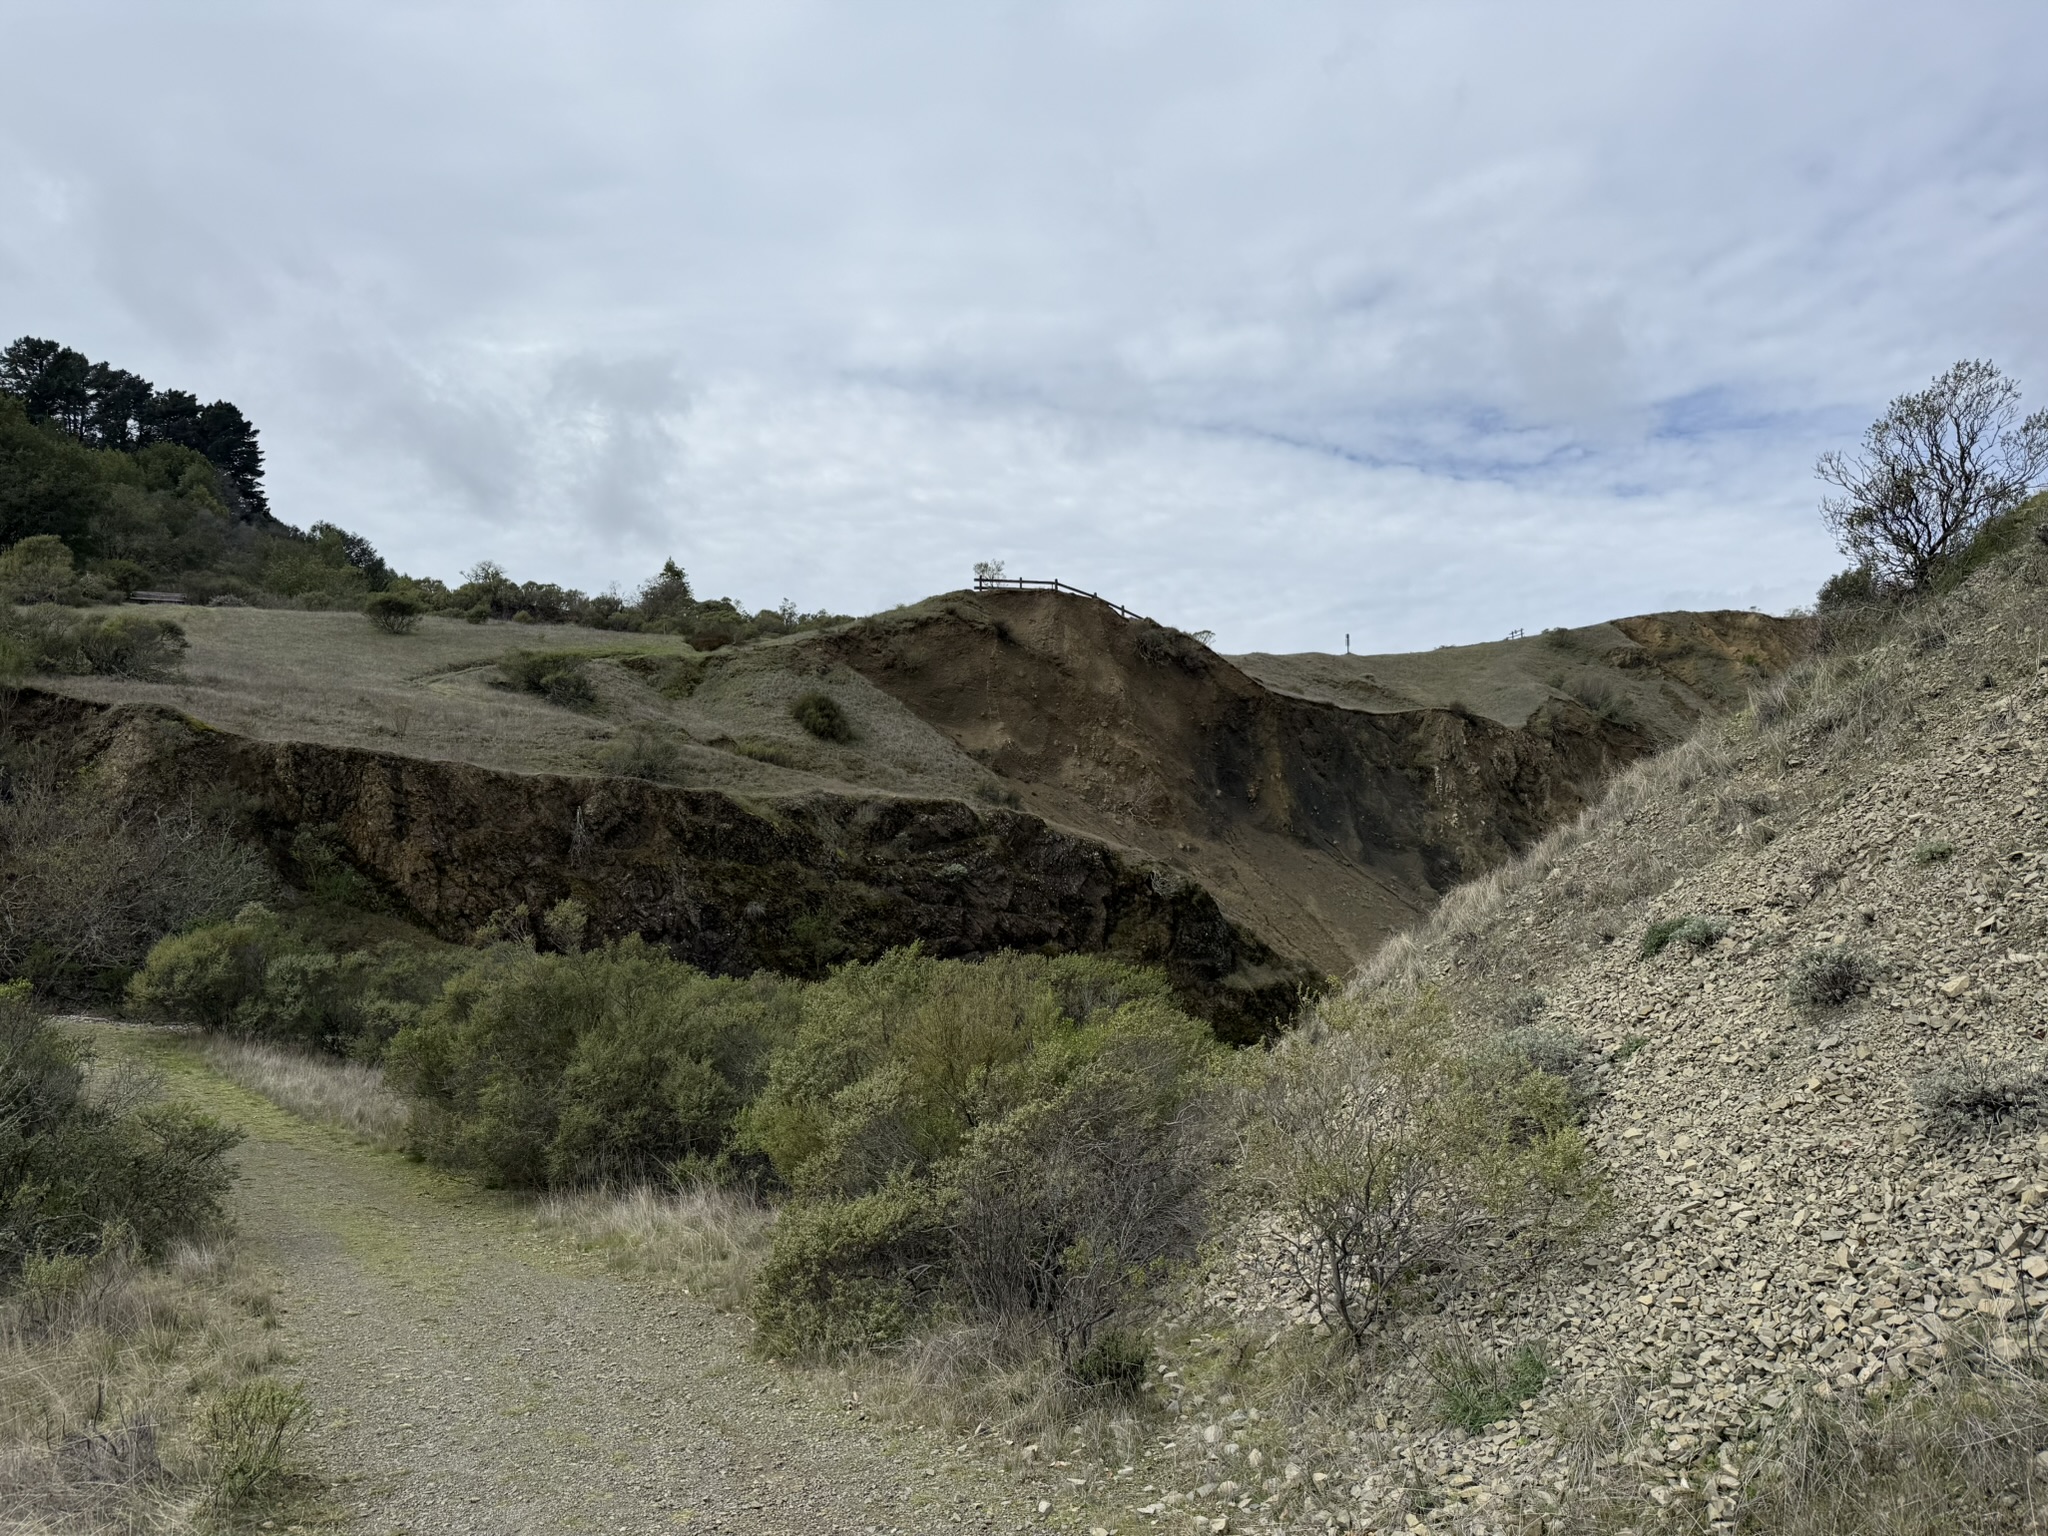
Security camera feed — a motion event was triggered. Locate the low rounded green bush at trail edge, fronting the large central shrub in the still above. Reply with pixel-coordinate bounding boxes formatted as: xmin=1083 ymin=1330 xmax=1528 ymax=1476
xmin=750 ymin=1178 xmax=942 ymax=1360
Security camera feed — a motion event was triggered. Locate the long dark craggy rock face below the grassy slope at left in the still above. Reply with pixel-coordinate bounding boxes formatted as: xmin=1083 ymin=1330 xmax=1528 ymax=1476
xmin=28 ymin=694 xmax=1313 ymax=1040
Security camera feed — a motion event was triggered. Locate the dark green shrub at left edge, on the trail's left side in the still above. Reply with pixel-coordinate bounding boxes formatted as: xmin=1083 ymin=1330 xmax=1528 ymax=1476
xmin=0 ymin=983 xmax=242 ymax=1288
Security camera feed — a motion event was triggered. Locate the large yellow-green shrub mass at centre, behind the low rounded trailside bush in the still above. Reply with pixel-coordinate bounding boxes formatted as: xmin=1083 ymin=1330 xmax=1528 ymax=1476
xmin=739 ymin=950 xmax=1223 ymax=1364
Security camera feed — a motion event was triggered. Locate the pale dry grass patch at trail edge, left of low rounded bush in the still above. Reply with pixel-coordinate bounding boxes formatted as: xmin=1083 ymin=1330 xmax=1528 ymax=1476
xmin=535 ymin=1184 xmax=774 ymax=1311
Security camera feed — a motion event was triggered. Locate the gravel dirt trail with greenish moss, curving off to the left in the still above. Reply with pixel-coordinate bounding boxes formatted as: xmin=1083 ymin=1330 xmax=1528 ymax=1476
xmin=106 ymin=1028 xmax=1015 ymax=1536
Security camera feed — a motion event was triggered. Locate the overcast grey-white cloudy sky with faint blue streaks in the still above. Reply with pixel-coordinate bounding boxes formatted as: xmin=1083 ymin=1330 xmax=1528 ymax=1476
xmin=0 ymin=0 xmax=2048 ymax=651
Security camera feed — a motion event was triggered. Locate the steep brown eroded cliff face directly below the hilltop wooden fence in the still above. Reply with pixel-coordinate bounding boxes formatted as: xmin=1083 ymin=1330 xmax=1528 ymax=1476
xmin=819 ymin=592 xmax=1663 ymax=973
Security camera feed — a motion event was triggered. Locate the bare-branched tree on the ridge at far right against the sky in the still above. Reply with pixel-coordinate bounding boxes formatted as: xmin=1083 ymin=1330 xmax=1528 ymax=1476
xmin=1815 ymin=360 xmax=2048 ymax=592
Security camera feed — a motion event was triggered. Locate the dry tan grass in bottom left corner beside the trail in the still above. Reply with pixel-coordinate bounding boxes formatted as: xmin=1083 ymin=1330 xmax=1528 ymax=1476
xmin=0 ymin=1247 xmax=292 ymax=1536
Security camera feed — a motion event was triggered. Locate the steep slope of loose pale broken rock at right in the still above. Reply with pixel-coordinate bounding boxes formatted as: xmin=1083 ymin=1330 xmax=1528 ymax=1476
xmin=1184 ymin=561 xmax=2048 ymax=1532
